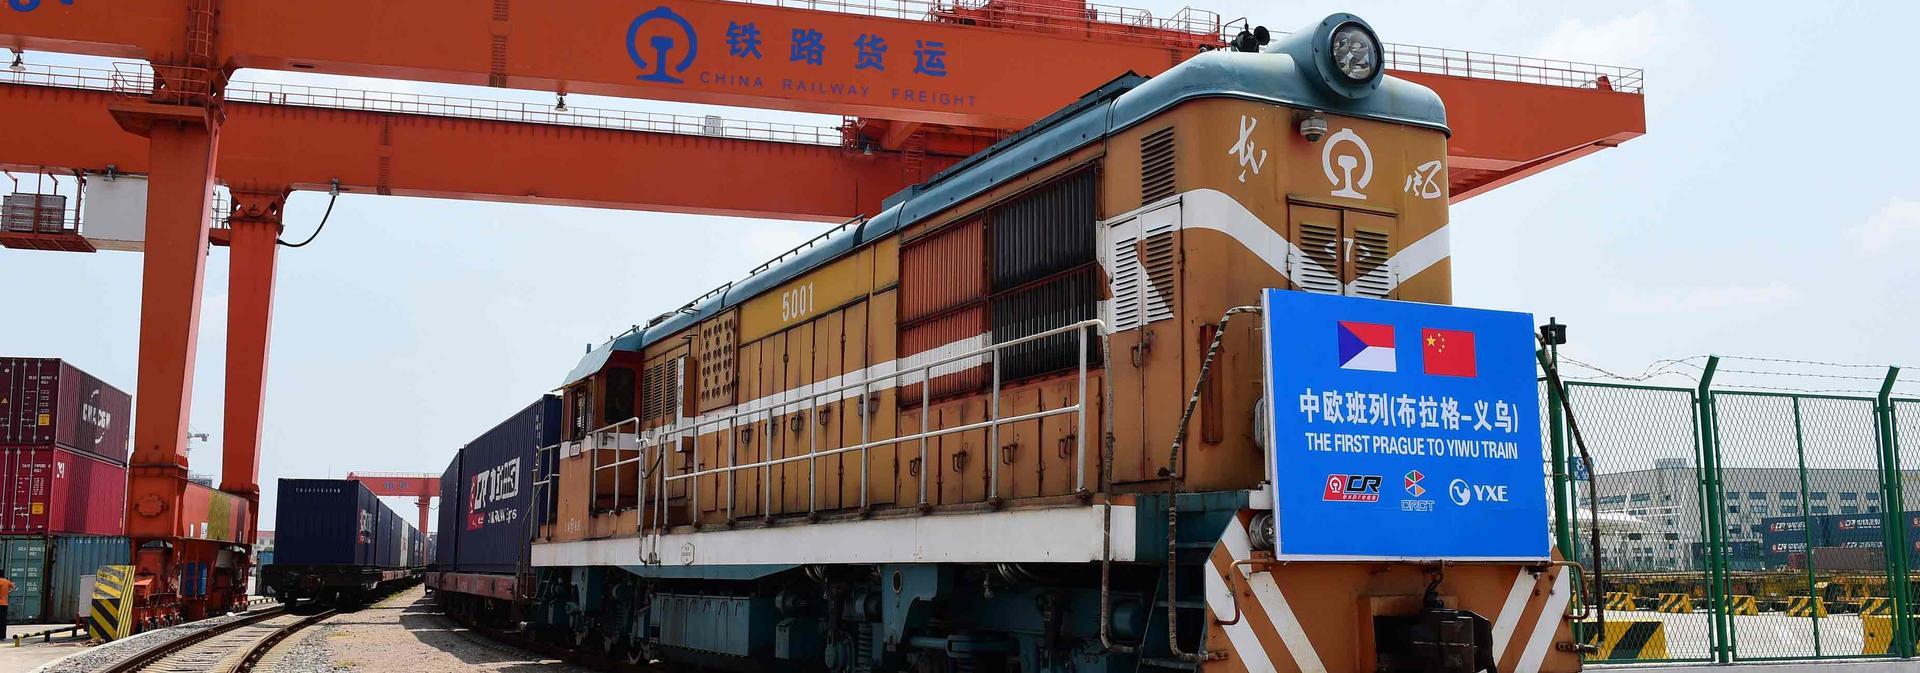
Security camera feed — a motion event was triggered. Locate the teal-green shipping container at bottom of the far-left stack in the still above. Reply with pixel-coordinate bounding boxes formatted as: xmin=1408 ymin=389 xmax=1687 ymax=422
xmin=0 ymin=535 xmax=132 ymax=623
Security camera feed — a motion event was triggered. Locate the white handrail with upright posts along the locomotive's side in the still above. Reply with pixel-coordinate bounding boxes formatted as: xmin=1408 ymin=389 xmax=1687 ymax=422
xmin=556 ymin=320 xmax=1106 ymax=535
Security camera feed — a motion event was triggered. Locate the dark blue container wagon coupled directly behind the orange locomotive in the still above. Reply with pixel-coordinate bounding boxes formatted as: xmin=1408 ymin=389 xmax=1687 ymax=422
xmin=426 ymin=395 xmax=561 ymax=627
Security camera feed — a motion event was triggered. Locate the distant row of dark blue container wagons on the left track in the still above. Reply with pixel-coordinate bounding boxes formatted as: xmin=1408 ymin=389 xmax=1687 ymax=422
xmin=261 ymin=479 xmax=426 ymax=606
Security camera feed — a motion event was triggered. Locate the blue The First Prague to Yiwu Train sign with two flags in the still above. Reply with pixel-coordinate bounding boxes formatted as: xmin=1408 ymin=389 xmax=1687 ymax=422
xmin=1263 ymin=290 xmax=1549 ymax=560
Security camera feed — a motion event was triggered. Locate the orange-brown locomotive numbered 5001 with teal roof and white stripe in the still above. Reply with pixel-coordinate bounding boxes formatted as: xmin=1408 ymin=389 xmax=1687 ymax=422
xmin=432 ymin=13 xmax=1580 ymax=673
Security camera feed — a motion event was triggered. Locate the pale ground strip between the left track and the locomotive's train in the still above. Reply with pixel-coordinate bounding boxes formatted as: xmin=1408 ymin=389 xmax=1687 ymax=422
xmin=255 ymin=587 xmax=593 ymax=673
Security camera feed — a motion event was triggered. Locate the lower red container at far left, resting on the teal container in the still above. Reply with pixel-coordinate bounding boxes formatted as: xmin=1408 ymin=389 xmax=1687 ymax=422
xmin=0 ymin=447 xmax=127 ymax=535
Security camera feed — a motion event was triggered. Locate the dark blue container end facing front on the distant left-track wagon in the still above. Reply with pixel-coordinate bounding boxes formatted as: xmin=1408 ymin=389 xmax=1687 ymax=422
xmin=275 ymin=479 xmax=384 ymax=566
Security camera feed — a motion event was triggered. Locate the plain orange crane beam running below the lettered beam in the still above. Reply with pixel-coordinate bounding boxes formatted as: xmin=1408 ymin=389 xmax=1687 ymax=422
xmin=0 ymin=84 xmax=936 ymax=220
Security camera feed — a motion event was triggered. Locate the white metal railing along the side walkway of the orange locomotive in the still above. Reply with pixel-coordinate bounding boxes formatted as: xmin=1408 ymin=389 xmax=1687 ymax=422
xmin=534 ymin=320 xmax=1106 ymax=558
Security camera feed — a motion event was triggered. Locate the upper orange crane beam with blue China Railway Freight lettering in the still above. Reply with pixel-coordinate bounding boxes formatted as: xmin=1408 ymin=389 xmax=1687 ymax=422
xmin=0 ymin=0 xmax=1219 ymax=128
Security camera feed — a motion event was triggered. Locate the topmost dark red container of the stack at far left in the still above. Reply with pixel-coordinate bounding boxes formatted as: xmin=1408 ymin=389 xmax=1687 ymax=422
xmin=0 ymin=357 xmax=132 ymax=464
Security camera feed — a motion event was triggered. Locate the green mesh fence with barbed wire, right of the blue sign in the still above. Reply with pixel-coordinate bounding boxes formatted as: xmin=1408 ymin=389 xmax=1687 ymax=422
xmin=1544 ymin=362 xmax=1920 ymax=663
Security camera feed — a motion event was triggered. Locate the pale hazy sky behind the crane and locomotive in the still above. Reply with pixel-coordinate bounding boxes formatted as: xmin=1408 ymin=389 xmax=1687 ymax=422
xmin=0 ymin=0 xmax=1920 ymax=529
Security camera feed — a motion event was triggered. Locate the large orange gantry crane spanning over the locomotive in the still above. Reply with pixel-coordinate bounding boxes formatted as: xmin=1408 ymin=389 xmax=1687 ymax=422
xmin=0 ymin=0 xmax=1645 ymax=621
